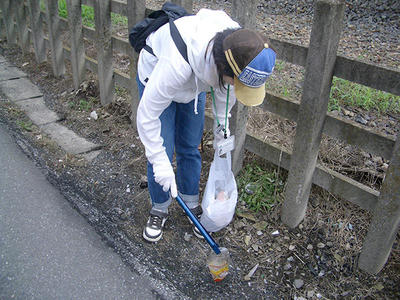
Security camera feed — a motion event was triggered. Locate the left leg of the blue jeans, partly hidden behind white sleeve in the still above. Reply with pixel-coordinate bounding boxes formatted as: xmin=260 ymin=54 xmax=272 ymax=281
xmin=136 ymin=77 xmax=176 ymax=213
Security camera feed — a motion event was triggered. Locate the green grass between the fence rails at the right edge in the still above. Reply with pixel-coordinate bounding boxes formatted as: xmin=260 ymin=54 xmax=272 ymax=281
xmin=328 ymin=77 xmax=400 ymax=113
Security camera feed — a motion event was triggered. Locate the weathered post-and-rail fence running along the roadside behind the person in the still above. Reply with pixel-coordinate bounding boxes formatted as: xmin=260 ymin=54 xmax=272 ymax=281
xmin=0 ymin=0 xmax=400 ymax=273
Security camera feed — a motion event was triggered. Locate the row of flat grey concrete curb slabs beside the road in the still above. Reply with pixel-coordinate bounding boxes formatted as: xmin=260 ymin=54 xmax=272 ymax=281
xmin=0 ymin=55 xmax=101 ymax=161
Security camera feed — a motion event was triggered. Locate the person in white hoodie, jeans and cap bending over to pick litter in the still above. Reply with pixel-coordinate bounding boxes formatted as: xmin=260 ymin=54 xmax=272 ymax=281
xmin=136 ymin=9 xmax=276 ymax=242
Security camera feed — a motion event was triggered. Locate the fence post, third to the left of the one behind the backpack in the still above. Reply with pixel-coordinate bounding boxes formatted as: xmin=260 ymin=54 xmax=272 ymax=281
xmin=46 ymin=0 xmax=65 ymax=77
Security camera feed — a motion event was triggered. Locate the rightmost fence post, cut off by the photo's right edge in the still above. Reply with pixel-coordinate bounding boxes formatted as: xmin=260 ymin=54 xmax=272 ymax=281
xmin=358 ymin=133 xmax=400 ymax=274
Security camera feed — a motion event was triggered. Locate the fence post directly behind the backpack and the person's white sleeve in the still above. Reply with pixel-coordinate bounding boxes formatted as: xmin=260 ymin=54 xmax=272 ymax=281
xmin=127 ymin=0 xmax=146 ymax=128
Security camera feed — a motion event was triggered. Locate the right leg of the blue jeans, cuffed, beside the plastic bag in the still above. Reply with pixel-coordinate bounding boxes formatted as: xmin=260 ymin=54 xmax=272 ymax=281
xmin=175 ymin=92 xmax=206 ymax=208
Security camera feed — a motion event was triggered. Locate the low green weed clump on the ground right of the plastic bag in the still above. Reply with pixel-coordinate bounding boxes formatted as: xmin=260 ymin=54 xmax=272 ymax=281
xmin=237 ymin=163 xmax=284 ymax=212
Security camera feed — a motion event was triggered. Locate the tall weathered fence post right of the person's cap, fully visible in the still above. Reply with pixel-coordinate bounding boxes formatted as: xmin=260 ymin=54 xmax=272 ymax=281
xmin=282 ymin=0 xmax=345 ymax=228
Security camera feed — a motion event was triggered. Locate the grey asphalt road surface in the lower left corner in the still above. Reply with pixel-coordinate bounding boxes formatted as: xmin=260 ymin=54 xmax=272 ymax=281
xmin=0 ymin=124 xmax=160 ymax=300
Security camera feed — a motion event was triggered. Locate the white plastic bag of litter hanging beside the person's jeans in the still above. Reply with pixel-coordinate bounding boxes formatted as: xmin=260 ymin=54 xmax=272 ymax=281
xmin=200 ymin=152 xmax=238 ymax=232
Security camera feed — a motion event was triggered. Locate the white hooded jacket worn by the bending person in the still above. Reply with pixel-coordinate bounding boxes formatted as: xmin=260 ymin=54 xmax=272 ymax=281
xmin=137 ymin=9 xmax=239 ymax=168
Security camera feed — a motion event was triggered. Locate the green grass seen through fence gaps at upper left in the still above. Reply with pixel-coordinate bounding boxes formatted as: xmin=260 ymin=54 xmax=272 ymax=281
xmin=40 ymin=0 xmax=128 ymax=28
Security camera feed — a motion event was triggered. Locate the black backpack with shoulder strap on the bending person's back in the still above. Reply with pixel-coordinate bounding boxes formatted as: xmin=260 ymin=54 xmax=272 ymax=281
xmin=129 ymin=2 xmax=191 ymax=63
